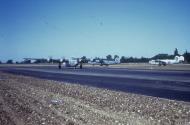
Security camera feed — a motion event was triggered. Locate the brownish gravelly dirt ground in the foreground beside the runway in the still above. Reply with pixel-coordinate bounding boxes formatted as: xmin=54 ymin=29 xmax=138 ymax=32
xmin=0 ymin=72 xmax=190 ymax=125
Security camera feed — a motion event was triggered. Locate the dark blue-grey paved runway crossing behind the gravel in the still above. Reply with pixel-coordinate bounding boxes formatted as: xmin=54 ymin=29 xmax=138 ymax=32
xmin=0 ymin=66 xmax=190 ymax=102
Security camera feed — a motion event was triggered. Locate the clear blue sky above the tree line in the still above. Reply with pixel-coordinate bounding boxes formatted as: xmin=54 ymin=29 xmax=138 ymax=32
xmin=0 ymin=0 xmax=190 ymax=61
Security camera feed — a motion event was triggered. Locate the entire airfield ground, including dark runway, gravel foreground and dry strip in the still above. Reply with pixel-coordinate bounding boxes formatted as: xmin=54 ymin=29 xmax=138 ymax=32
xmin=0 ymin=64 xmax=190 ymax=125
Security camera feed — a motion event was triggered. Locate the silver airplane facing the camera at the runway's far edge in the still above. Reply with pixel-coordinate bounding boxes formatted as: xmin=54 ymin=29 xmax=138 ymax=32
xmin=62 ymin=57 xmax=83 ymax=69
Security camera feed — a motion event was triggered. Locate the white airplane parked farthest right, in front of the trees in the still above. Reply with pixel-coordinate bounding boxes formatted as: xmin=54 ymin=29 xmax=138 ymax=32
xmin=149 ymin=56 xmax=184 ymax=66
